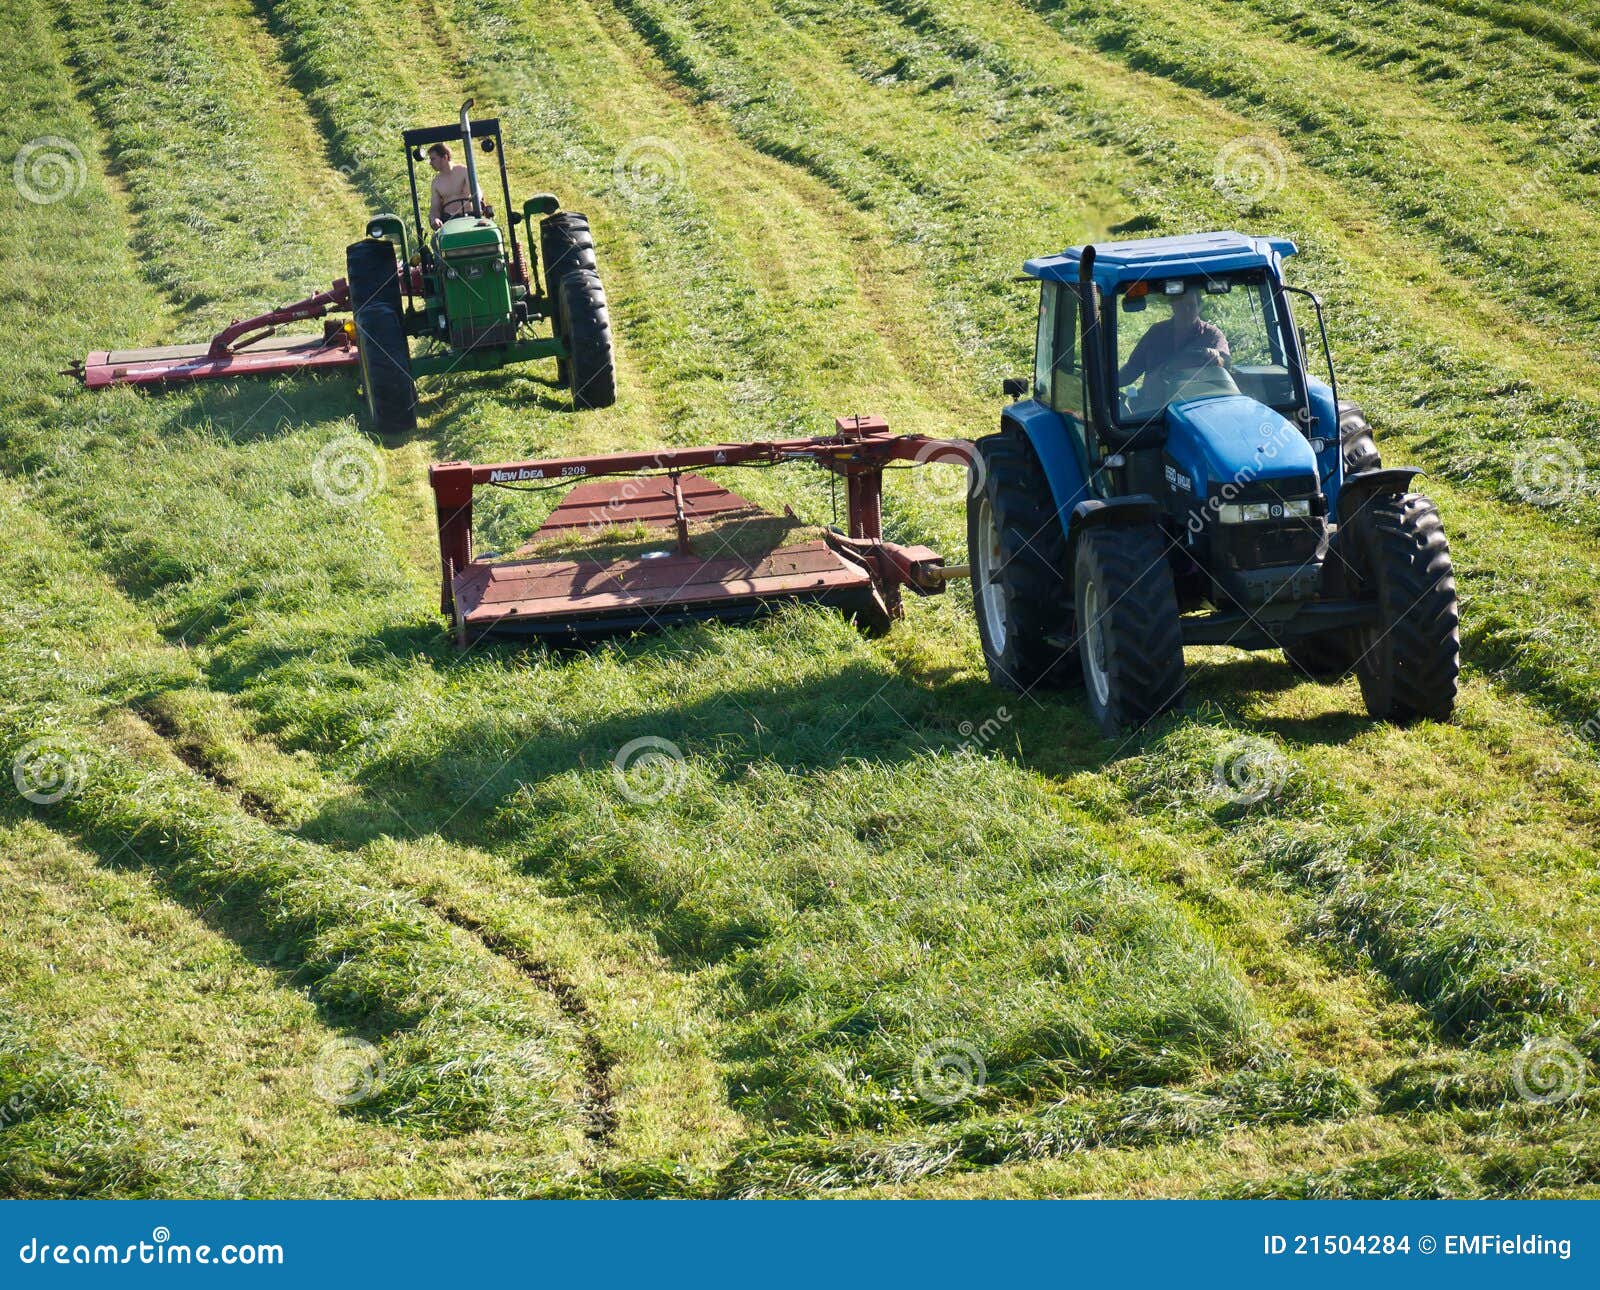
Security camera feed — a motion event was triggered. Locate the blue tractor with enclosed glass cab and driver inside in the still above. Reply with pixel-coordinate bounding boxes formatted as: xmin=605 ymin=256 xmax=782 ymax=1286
xmin=968 ymin=232 xmax=1459 ymax=735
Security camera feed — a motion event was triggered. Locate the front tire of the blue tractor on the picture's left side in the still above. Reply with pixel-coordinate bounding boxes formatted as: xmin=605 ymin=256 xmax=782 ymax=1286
xmin=1072 ymin=525 xmax=1184 ymax=736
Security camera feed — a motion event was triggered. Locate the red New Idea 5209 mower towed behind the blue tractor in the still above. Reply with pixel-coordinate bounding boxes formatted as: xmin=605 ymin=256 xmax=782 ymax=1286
xmin=430 ymin=418 xmax=966 ymax=645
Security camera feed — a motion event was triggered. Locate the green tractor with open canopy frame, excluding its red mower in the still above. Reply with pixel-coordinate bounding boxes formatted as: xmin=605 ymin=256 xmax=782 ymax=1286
xmin=346 ymin=99 xmax=616 ymax=437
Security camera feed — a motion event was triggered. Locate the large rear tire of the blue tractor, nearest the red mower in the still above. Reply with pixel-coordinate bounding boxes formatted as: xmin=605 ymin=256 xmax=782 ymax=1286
xmin=966 ymin=431 xmax=1077 ymax=691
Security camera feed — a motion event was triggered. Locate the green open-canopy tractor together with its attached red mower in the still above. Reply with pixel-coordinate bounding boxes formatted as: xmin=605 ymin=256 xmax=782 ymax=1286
xmin=67 ymin=99 xmax=616 ymax=439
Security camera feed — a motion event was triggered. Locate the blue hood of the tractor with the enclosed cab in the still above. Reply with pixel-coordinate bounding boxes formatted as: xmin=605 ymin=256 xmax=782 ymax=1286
xmin=1166 ymin=394 xmax=1318 ymax=496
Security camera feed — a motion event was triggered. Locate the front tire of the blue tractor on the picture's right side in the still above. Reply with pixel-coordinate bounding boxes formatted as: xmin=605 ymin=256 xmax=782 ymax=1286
xmin=1349 ymin=493 xmax=1461 ymax=723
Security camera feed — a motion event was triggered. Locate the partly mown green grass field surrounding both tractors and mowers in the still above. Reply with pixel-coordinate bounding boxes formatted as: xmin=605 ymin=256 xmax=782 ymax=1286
xmin=0 ymin=0 xmax=1600 ymax=1197
